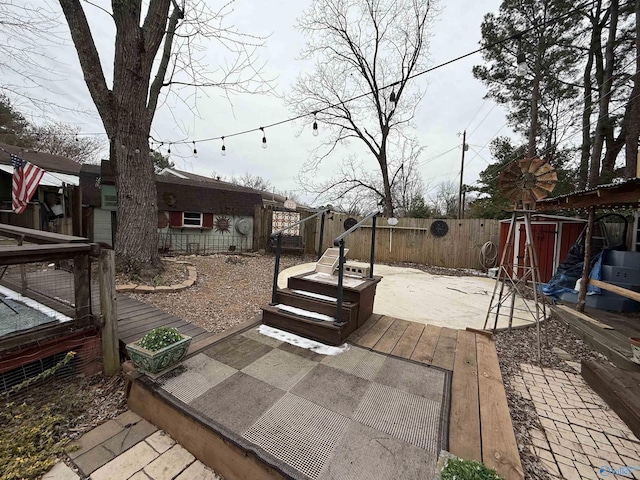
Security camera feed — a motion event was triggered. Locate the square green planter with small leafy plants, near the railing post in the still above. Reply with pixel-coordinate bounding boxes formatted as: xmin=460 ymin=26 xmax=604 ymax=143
xmin=126 ymin=327 xmax=191 ymax=379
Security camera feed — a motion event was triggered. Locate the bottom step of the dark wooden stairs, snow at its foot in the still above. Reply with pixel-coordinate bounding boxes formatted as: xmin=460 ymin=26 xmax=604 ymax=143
xmin=262 ymin=305 xmax=356 ymax=345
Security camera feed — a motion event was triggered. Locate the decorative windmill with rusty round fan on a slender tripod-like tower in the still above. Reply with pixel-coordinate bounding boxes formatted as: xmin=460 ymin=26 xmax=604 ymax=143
xmin=483 ymin=158 xmax=558 ymax=361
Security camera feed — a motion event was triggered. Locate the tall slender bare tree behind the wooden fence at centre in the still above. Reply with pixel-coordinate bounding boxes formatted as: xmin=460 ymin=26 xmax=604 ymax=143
xmin=289 ymin=0 xmax=434 ymax=214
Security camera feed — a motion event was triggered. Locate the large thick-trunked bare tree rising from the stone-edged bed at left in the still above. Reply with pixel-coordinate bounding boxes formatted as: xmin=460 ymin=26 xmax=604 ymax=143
xmin=59 ymin=0 xmax=262 ymax=273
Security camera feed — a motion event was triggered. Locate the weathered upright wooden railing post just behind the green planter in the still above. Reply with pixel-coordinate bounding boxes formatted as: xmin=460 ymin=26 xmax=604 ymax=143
xmin=98 ymin=249 xmax=120 ymax=376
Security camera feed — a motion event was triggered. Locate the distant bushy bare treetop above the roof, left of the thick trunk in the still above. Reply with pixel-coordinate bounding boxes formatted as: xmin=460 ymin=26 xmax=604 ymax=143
xmin=31 ymin=122 xmax=106 ymax=163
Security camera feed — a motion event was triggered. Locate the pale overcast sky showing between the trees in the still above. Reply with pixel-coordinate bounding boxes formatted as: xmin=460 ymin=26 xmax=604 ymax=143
xmin=7 ymin=0 xmax=513 ymax=203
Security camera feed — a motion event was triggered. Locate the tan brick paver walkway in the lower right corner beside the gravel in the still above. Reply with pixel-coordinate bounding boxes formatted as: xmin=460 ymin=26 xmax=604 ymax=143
xmin=514 ymin=364 xmax=640 ymax=480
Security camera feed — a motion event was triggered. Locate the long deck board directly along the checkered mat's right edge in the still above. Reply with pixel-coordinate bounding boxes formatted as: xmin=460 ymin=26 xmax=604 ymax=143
xmin=449 ymin=331 xmax=482 ymax=461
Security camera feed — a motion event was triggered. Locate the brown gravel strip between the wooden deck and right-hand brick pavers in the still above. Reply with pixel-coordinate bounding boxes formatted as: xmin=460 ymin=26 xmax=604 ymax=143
xmin=494 ymin=317 xmax=608 ymax=480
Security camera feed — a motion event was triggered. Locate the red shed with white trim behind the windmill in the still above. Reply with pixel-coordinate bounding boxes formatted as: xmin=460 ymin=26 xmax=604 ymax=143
xmin=499 ymin=214 xmax=587 ymax=282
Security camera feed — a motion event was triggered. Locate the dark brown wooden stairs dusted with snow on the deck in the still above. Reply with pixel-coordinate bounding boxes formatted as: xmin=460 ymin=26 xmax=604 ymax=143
xmin=262 ymin=248 xmax=380 ymax=345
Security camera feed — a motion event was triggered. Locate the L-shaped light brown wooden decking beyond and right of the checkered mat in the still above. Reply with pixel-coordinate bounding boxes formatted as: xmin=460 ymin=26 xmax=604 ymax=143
xmin=348 ymin=314 xmax=524 ymax=480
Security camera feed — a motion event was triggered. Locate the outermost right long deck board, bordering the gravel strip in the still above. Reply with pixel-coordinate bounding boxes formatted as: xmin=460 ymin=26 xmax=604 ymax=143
xmin=476 ymin=335 xmax=524 ymax=480
